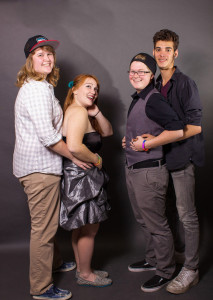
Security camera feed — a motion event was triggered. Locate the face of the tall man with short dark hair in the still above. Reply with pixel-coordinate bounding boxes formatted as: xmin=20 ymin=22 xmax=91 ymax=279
xmin=153 ymin=41 xmax=178 ymax=70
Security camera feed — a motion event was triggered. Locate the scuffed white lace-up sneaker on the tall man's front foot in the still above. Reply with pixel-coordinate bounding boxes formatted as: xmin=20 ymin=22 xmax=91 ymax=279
xmin=166 ymin=267 xmax=199 ymax=294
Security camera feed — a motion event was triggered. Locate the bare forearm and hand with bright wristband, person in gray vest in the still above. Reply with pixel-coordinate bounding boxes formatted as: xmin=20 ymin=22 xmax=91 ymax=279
xmin=130 ymin=130 xmax=183 ymax=151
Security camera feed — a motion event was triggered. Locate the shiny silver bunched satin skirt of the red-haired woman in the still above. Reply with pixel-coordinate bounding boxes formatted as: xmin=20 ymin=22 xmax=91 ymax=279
xmin=60 ymin=159 xmax=110 ymax=230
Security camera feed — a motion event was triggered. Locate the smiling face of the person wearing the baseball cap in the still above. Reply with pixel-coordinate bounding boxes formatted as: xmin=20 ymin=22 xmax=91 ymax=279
xmin=32 ymin=48 xmax=54 ymax=77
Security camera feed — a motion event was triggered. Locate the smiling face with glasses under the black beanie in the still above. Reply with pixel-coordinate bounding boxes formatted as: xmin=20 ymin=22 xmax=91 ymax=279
xmin=129 ymin=61 xmax=154 ymax=93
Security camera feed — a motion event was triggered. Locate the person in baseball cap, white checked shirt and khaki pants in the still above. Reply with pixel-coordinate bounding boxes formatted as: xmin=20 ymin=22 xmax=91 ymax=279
xmin=13 ymin=35 xmax=89 ymax=299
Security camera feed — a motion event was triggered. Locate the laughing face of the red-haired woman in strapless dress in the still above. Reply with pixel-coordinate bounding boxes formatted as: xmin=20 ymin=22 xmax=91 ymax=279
xmin=73 ymin=77 xmax=98 ymax=107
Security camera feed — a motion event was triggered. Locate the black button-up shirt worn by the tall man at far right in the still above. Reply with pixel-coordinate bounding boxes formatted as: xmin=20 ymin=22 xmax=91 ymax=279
xmin=156 ymin=67 xmax=204 ymax=170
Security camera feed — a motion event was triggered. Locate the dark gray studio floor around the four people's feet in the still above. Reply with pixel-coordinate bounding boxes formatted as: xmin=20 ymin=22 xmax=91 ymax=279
xmin=0 ymin=234 xmax=213 ymax=300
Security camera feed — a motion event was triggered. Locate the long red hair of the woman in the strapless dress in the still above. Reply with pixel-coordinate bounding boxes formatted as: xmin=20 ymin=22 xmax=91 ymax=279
xmin=63 ymin=74 xmax=102 ymax=133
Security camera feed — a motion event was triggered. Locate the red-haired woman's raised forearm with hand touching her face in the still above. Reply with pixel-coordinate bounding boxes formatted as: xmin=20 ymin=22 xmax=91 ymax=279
xmin=87 ymin=104 xmax=113 ymax=137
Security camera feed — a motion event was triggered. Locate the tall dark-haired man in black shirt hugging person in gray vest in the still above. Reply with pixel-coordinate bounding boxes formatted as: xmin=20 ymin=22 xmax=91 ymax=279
xmin=153 ymin=29 xmax=204 ymax=294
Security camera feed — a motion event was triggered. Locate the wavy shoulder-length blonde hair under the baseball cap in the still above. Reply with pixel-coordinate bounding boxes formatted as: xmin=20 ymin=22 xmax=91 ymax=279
xmin=16 ymin=46 xmax=59 ymax=87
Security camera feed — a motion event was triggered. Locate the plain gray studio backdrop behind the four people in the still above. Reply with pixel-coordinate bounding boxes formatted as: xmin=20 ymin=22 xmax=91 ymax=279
xmin=0 ymin=0 xmax=213 ymax=256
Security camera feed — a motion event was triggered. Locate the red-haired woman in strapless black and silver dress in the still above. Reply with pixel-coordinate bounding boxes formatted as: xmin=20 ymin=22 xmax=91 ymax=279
xmin=60 ymin=74 xmax=113 ymax=287
